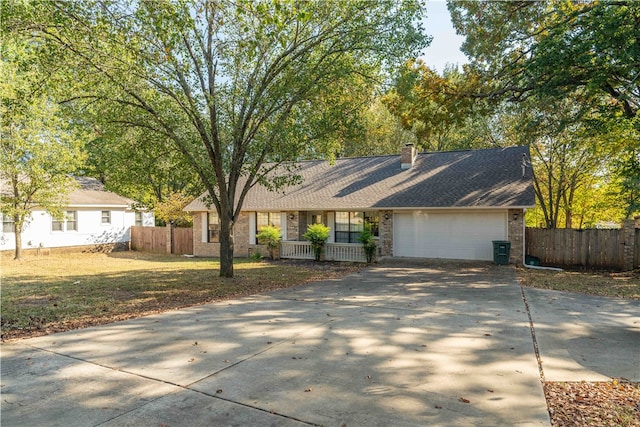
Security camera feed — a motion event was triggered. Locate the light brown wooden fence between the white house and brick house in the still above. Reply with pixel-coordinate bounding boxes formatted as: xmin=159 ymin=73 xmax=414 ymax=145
xmin=131 ymin=226 xmax=193 ymax=255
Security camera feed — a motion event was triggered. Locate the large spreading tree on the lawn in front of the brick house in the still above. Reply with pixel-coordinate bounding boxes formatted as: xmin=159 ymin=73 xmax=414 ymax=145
xmin=21 ymin=0 xmax=426 ymax=277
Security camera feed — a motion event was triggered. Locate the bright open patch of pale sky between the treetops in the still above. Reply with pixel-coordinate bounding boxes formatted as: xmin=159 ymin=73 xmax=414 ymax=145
xmin=421 ymin=0 xmax=469 ymax=72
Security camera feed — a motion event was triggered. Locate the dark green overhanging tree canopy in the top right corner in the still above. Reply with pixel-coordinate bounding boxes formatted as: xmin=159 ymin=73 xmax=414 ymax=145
xmin=448 ymin=1 xmax=640 ymax=118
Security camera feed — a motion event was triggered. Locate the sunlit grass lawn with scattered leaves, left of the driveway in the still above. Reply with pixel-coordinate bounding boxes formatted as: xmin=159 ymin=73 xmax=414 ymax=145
xmin=0 ymin=252 xmax=360 ymax=340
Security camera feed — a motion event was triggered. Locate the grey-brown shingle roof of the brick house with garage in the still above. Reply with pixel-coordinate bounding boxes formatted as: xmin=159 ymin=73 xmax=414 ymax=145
xmin=185 ymin=146 xmax=535 ymax=211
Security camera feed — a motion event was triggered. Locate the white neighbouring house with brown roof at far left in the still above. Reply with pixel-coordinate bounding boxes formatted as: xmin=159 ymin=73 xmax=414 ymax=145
xmin=0 ymin=177 xmax=155 ymax=254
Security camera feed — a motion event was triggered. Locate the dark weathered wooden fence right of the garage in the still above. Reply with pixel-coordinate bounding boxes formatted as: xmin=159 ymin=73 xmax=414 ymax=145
xmin=525 ymin=227 xmax=640 ymax=270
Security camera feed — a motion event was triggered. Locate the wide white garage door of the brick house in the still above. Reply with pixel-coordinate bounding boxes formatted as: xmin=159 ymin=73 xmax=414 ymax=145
xmin=393 ymin=212 xmax=507 ymax=261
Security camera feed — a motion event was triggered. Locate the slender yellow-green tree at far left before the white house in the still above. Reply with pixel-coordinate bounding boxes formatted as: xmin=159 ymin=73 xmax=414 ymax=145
xmin=0 ymin=31 xmax=85 ymax=259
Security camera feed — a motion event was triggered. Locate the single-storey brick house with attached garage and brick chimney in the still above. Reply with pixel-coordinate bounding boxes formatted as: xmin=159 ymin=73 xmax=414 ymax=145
xmin=185 ymin=149 xmax=535 ymax=264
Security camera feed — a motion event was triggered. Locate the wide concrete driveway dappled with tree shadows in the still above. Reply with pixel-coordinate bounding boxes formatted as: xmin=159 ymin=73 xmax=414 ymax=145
xmin=0 ymin=261 xmax=640 ymax=427
